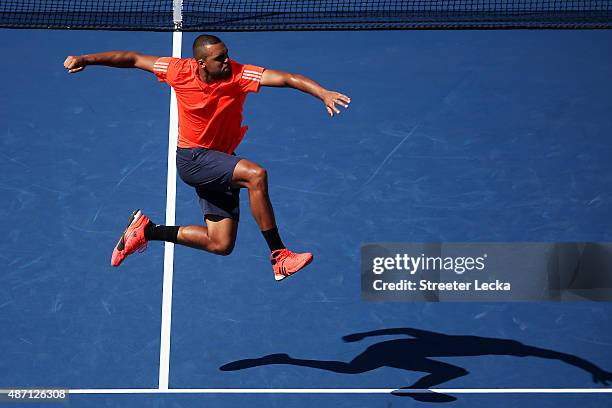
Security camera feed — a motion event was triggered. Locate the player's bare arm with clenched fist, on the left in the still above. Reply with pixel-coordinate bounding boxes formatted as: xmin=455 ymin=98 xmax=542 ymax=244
xmin=64 ymin=51 xmax=159 ymax=74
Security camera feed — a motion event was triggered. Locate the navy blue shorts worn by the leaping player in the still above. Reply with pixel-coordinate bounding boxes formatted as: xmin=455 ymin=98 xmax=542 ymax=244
xmin=176 ymin=147 xmax=241 ymax=220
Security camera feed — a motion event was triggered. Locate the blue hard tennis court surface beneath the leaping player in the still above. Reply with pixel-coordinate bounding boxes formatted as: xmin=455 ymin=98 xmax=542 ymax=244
xmin=0 ymin=11 xmax=612 ymax=408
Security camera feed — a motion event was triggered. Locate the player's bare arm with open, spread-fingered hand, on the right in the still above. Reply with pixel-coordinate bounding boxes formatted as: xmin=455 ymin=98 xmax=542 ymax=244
xmin=261 ymin=69 xmax=351 ymax=116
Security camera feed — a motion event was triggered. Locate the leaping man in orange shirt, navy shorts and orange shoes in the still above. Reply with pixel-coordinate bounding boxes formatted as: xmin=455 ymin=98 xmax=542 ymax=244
xmin=64 ymin=35 xmax=350 ymax=280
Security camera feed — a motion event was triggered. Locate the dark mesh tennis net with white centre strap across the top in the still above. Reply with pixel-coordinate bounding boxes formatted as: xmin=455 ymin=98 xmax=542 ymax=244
xmin=0 ymin=0 xmax=612 ymax=31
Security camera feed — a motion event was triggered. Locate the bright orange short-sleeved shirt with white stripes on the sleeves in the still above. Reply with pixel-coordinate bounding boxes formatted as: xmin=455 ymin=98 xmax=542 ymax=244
xmin=153 ymin=57 xmax=264 ymax=154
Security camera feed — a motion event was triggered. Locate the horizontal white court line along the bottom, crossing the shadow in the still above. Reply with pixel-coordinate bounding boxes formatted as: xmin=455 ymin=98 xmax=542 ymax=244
xmin=53 ymin=388 xmax=612 ymax=394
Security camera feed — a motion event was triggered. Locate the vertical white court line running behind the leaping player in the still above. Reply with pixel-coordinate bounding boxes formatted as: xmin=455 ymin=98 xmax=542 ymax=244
xmin=159 ymin=31 xmax=183 ymax=390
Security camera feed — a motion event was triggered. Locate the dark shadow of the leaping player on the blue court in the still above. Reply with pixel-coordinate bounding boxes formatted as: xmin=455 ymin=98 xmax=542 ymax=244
xmin=219 ymin=328 xmax=612 ymax=402
